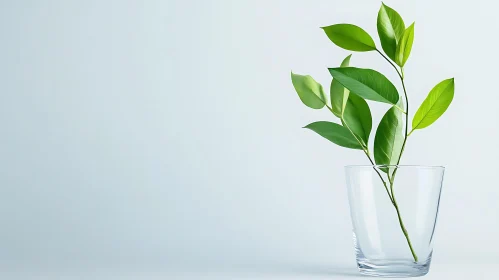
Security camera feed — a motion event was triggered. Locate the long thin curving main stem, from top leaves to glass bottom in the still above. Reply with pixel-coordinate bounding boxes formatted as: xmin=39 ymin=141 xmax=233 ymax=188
xmin=376 ymin=49 xmax=418 ymax=262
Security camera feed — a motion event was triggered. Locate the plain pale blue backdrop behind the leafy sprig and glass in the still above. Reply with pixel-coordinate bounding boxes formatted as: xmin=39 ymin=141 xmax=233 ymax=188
xmin=0 ymin=0 xmax=499 ymax=279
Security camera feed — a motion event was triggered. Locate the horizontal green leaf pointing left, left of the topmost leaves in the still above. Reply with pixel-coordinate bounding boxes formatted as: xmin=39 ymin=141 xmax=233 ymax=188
xmin=322 ymin=23 xmax=376 ymax=52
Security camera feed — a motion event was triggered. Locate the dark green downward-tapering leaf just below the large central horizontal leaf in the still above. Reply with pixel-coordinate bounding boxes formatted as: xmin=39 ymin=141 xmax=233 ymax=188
xmin=341 ymin=94 xmax=373 ymax=147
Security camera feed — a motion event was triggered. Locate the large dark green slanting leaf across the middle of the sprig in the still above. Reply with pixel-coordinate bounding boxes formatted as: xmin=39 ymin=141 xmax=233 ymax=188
xmin=329 ymin=67 xmax=399 ymax=105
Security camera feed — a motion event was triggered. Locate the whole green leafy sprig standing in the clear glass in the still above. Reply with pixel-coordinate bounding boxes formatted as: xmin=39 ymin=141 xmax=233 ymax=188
xmin=291 ymin=3 xmax=454 ymax=262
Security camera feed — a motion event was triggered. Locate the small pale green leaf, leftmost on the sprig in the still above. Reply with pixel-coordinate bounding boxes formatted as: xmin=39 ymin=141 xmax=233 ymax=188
xmin=291 ymin=72 xmax=326 ymax=109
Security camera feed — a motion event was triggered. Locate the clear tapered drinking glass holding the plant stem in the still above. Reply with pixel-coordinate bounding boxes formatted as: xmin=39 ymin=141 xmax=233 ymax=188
xmin=345 ymin=165 xmax=444 ymax=277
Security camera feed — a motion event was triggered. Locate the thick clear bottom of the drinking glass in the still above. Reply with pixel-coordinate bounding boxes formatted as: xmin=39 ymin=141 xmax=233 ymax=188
xmin=357 ymin=256 xmax=431 ymax=277
